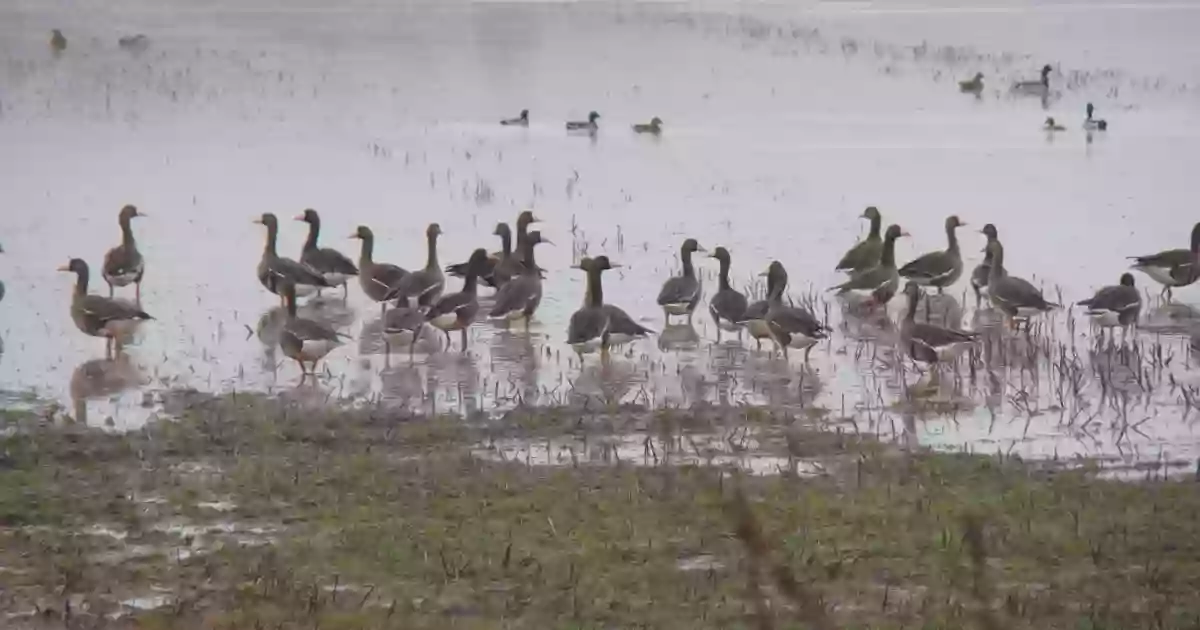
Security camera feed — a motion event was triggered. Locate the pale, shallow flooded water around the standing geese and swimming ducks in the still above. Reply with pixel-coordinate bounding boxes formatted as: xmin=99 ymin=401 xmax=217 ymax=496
xmin=0 ymin=0 xmax=1200 ymax=460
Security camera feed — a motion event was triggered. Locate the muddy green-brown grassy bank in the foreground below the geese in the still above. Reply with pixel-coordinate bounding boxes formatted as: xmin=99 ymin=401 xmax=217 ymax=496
xmin=0 ymin=396 xmax=1200 ymax=629
